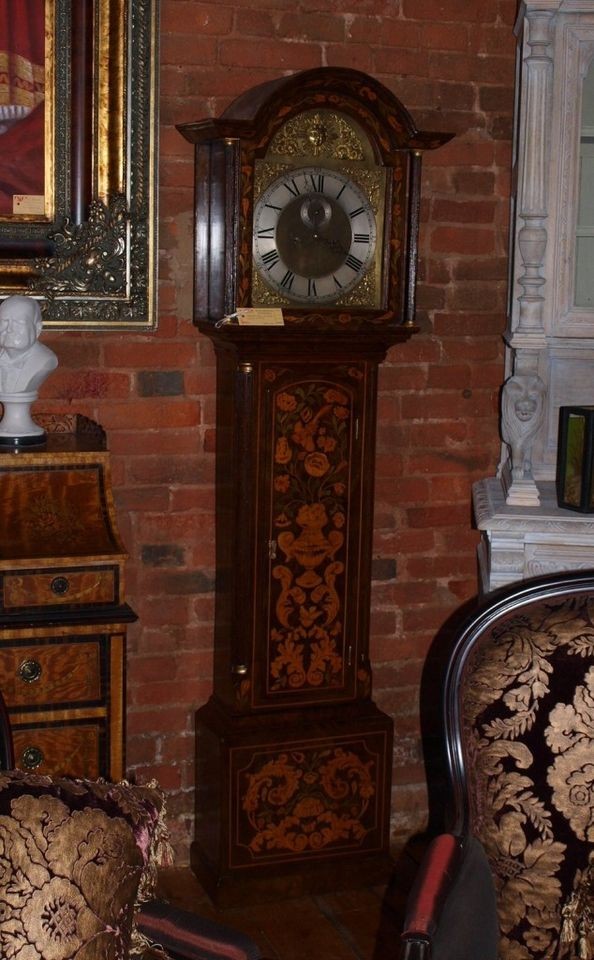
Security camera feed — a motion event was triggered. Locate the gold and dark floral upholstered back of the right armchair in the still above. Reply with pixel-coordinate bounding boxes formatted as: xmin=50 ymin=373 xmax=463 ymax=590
xmin=459 ymin=590 xmax=594 ymax=960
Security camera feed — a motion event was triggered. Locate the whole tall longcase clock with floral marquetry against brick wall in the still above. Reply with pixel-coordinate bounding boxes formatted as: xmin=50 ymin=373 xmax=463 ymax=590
xmin=180 ymin=68 xmax=450 ymax=903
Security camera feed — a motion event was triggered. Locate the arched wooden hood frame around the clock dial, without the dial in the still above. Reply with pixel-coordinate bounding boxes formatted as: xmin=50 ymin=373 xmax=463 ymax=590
xmin=178 ymin=67 xmax=452 ymax=339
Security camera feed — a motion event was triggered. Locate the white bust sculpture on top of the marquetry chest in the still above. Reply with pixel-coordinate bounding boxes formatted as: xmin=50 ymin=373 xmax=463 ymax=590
xmin=0 ymin=296 xmax=58 ymax=445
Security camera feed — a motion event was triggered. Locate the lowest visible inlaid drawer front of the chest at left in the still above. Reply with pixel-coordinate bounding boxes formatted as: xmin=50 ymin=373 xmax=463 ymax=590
xmin=13 ymin=721 xmax=105 ymax=779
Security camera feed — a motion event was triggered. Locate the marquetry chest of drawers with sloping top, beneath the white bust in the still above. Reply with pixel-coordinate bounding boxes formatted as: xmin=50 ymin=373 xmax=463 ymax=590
xmin=0 ymin=415 xmax=135 ymax=780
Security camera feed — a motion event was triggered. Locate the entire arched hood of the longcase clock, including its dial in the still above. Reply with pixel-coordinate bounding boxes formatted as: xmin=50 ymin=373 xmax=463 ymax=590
xmin=179 ymin=67 xmax=451 ymax=334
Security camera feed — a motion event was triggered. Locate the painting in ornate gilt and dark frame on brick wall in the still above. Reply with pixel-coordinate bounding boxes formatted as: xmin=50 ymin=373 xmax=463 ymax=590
xmin=0 ymin=0 xmax=158 ymax=330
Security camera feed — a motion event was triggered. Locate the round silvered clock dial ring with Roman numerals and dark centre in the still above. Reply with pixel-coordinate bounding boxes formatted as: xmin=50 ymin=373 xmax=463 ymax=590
xmin=253 ymin=166 xmax=377 ymax=305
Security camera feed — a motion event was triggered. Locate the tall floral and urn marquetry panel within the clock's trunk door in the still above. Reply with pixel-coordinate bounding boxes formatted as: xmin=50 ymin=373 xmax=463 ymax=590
xmin=265 ymin=366 xmax=363 ymax=693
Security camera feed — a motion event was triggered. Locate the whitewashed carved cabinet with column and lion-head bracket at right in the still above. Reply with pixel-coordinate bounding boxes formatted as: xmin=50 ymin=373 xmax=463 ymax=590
xmin=473 ymin=0 xmax=594 ymax=586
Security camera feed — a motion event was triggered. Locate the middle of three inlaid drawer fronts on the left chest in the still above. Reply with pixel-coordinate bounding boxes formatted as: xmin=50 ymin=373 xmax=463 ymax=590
xmin=0 ymin=638 xmax=103 ymax=709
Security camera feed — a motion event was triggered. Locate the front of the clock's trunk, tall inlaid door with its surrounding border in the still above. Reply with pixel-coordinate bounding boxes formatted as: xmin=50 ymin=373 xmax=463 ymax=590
xmin=252 ymin=361 xmax=375 ymax=707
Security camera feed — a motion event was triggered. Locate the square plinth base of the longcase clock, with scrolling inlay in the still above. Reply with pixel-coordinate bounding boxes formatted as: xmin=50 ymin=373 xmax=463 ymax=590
xmin=192 ymin=699 xmax=393 ymax=906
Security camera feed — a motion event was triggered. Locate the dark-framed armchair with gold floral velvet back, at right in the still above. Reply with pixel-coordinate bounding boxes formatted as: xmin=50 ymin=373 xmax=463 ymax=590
xmin=402 ymin=571 xmax=594 ymax=960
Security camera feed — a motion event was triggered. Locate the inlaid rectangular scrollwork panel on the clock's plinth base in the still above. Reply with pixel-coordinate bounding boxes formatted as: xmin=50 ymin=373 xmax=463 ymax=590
xmin=230 ymin=725 xmax=390 ymax=866
